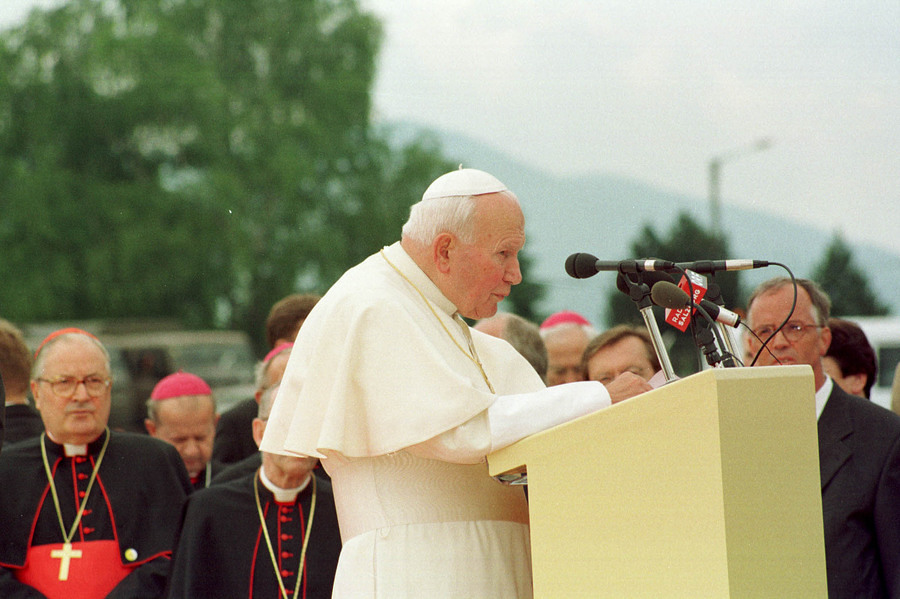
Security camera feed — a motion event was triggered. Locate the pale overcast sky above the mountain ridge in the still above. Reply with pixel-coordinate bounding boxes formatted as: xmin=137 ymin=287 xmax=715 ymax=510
xmin=7 ymin=0 xmax=900 ymax=253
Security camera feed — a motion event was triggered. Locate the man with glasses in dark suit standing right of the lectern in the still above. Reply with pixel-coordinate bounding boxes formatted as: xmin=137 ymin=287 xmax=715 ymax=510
xmin=747 ymin=278 xmax=900 ymax=598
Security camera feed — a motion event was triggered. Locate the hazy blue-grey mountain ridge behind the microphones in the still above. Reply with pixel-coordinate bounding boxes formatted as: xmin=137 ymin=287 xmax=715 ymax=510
xmin=395 ymin=123 xmax=900 ymax=329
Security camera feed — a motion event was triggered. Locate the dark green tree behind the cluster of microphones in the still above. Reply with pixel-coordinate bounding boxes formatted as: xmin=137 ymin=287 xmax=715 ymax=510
xmin=606 ymin=212 xmax=740 ymax=375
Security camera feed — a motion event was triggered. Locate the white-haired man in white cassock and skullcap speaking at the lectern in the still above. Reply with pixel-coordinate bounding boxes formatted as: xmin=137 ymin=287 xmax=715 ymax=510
xmin=260 ymin=169 xmax=650 ymax=599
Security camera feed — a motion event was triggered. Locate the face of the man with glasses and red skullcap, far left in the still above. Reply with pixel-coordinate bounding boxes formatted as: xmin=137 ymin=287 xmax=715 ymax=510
xmin=31 ymin=335 xmax=111 ymax=445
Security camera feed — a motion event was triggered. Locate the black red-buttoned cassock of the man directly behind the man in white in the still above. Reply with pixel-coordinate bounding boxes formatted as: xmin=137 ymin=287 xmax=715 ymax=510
xmin=169 ymin=472 xmax=341 ymax=599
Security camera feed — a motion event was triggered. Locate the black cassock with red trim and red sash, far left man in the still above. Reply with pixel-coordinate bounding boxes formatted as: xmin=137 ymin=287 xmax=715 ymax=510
xmin=0 ymin=432 xmax=191 ymax=599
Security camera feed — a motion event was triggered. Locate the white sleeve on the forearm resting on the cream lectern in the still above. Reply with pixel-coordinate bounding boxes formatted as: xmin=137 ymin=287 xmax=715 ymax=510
xmin=487 ymin=381 xmax=612 ymax=452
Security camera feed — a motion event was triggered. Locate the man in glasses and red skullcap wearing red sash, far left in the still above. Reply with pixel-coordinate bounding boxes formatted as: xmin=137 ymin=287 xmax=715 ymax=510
xmin=0 ymin=329 xmax=191 ymax=599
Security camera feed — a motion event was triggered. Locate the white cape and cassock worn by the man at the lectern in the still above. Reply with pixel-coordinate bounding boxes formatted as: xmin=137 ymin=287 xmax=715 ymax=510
xmin=261 ymin=243 xmax=608 ymax=598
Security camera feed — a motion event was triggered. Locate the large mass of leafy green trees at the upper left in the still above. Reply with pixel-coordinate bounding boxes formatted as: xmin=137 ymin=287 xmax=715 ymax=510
xmin=0 ymin=0 xmax=506 ymax=352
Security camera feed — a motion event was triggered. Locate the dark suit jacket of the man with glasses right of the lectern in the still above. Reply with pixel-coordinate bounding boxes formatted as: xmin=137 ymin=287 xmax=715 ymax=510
xmin=818 ymin=384 xmax=900 ymax=599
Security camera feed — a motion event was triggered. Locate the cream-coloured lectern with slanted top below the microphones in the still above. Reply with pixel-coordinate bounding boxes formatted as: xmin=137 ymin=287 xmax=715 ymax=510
xmin=488 ymin=366 xmax=827 ymax=598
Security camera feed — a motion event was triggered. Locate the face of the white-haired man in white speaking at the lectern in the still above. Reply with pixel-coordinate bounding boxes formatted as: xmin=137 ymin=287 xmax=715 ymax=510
xmin=445 ymin=193 xmax=525 ymax=319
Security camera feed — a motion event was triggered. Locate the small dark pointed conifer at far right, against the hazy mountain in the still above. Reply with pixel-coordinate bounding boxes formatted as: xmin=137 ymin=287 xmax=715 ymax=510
xmin=812 ymin=232 xmax=890 ymax=316
